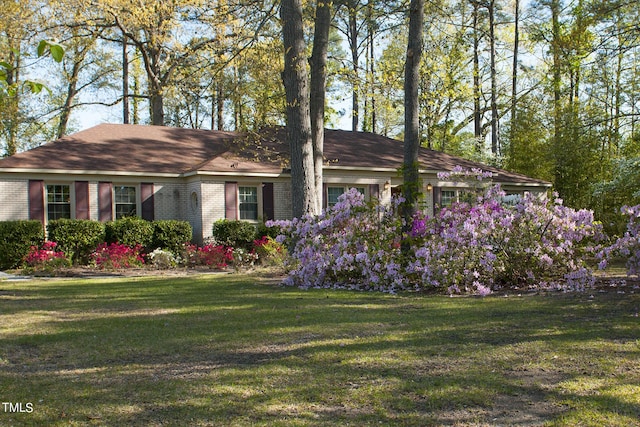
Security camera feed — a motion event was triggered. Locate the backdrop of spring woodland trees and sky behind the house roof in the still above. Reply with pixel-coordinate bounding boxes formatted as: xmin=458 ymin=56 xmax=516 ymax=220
xmin=0 ymin=0 xmax=640 ymax=224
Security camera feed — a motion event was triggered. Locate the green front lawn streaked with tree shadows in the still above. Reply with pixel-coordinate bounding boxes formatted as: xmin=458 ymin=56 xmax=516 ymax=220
xmin=0 ymin=275 xmax=640 ymax=426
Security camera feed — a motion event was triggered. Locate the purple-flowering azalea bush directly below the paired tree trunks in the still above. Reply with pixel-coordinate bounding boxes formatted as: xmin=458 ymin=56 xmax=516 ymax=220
xmin=267 ymin=189 xmax=405 ymax=291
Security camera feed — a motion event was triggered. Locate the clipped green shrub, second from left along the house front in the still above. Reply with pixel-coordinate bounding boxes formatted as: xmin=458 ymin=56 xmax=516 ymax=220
xmin=47 ymin=219 xmax=105 ymax=263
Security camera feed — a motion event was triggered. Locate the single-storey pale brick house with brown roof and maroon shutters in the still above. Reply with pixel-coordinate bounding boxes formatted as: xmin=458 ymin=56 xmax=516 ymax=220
xmin=0 ymin=124 xmax=550 ymax=242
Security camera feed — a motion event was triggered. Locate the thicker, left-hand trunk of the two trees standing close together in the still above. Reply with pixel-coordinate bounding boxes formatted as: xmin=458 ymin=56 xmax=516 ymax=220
xmin=280 ymin=0 xmax=319 ymax=218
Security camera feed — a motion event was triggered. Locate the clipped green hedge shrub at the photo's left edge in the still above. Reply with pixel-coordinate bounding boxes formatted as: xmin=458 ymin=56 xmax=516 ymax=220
xmin=0 ymin=220 xmax=44 ymax=270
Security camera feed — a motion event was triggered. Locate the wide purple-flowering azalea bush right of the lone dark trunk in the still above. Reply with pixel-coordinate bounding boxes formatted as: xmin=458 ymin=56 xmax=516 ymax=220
xmin=407 ymin=186 xmax=602 ymax=294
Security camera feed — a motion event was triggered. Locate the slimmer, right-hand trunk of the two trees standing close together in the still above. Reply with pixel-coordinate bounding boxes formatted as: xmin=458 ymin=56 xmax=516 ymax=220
xmin=310 ymin=2 xmax=331 ymax=212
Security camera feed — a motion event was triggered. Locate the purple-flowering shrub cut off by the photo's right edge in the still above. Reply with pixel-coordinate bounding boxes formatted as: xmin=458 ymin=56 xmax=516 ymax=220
xmin=598 ymin=205 xmax=640 ymax=275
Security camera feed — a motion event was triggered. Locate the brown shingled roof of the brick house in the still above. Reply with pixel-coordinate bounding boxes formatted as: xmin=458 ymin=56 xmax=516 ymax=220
xmin=0 ymin=124 xmax=548 ymax=185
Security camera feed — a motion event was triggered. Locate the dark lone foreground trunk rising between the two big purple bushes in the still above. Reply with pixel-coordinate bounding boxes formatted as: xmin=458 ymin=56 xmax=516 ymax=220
xmin=403 ymin=0 xmax=425 ymax=224
